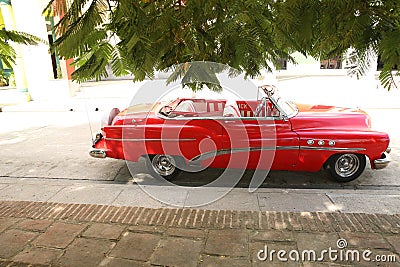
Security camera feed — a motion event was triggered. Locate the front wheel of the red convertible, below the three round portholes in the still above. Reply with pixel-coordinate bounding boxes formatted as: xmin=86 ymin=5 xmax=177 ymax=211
xmin=328 ymin=154 xmax=366 ymax=182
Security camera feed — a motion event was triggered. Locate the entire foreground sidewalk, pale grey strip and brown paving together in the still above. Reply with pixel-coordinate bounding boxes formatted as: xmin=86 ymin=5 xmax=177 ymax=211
xmin=0 ymin=177 xmax=400 ymax=267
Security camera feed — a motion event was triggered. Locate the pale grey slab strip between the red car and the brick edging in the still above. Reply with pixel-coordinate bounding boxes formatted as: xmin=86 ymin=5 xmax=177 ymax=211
xmin=0 ymin=178 xmax=400 ymax=216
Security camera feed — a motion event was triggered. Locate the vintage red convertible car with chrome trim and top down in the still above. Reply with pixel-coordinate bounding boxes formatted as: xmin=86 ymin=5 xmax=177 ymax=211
xmin=90 ymin=86 xmax=390 ymax=182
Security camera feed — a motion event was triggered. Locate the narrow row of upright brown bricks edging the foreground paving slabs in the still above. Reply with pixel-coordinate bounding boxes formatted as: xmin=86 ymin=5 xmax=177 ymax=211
xmin=0 ymin=201 xmax=400 ymax=234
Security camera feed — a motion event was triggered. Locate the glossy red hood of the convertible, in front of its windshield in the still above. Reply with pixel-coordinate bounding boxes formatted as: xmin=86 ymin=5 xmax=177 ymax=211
xmin=290 ymin=104 xmax=371 ymax=131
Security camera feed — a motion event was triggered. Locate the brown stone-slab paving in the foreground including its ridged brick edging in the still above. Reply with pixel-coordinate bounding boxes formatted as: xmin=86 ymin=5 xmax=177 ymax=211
xmin=0 ymin=201 xmax=400 ymax=267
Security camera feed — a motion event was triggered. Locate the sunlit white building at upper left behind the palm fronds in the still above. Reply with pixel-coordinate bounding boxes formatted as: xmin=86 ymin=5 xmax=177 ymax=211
xmin=0 ymin=0 xmax=79 ymax=100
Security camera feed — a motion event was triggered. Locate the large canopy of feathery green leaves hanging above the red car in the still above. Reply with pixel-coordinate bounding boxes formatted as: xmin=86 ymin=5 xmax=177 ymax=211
xmin=48 ymin=0 xmax=400 ymax=90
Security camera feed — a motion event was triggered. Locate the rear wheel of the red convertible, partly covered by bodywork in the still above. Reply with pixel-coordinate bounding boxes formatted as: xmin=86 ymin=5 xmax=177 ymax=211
xmin=146 ymin=155 xmax=182 ymax=181
